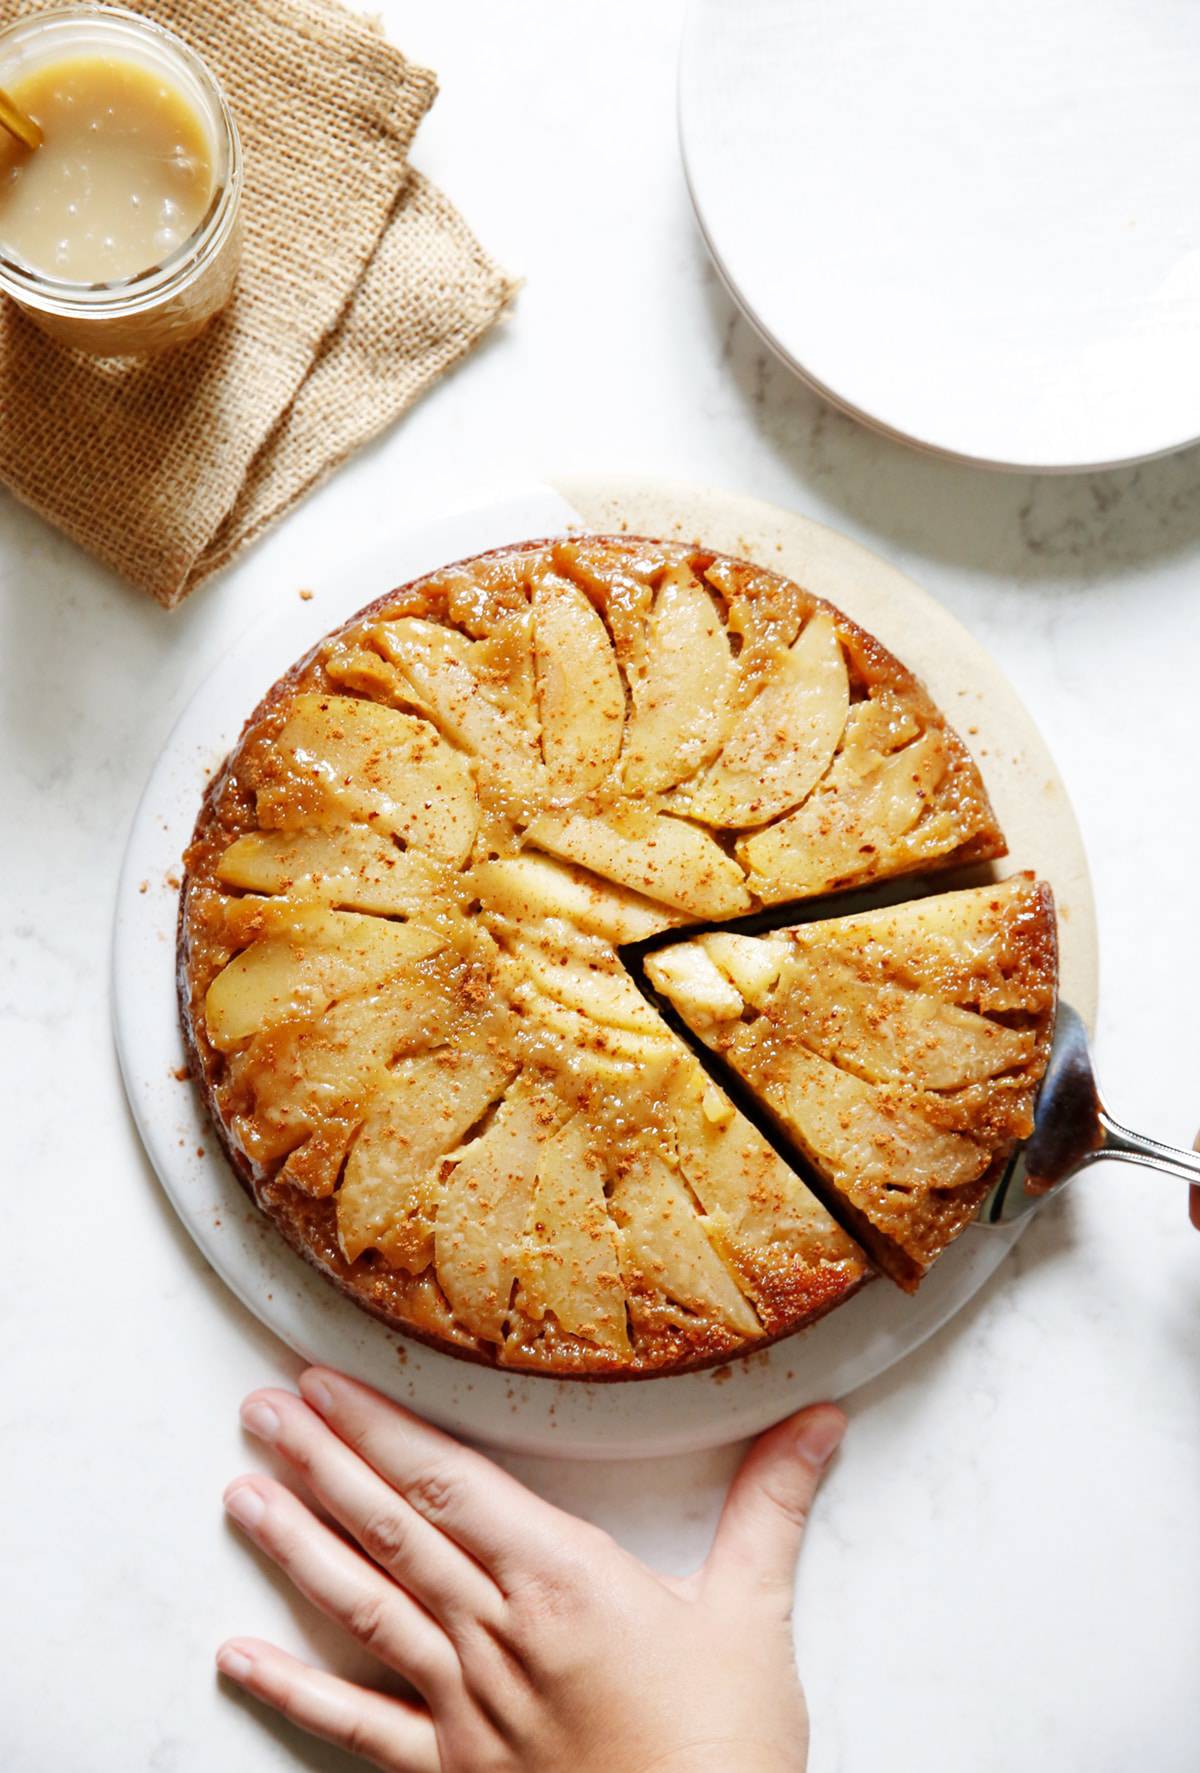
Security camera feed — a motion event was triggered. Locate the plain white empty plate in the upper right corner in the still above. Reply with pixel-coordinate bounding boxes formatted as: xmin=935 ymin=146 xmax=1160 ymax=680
xmin=679 ymin=0 xmax=1200 ymax=470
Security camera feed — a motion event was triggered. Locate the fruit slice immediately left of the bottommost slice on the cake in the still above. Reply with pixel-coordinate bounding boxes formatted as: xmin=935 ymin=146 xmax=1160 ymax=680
xmin=434 ymin=1082 xmax=560 ymax=1342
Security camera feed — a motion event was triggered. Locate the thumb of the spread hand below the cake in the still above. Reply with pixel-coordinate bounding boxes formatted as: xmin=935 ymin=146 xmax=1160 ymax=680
xmin=704 ymin=1404 xmax=845 ymax=1610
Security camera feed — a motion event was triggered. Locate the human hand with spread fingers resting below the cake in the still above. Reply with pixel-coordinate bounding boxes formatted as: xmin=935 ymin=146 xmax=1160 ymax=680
xmin=216 ymin=1367 xmax=845 ymax=1773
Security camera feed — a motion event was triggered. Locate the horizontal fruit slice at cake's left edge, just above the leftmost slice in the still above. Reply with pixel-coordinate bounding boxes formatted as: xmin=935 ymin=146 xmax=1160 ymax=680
xmin=216 ymin=824 xmax=457 ymax=917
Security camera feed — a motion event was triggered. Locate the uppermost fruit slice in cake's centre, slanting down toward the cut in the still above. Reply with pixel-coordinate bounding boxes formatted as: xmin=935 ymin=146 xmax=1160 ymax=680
xmin=526 ymin=812 xmax=750 ymax=917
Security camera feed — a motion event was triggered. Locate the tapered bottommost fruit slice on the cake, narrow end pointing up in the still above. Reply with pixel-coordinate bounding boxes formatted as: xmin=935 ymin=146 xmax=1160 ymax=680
xmin=519 ymin=1115 xmax=629 ymax=1353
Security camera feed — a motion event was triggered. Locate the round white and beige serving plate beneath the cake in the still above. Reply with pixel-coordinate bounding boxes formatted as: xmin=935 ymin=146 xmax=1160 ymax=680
xmin=113 ymin=482 xmax=1094 ymax=1457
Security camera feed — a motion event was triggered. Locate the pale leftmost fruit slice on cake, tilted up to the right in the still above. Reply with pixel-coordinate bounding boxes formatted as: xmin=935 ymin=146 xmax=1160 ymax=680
xmin=204 ymin=906 xmax=445 ymax=1053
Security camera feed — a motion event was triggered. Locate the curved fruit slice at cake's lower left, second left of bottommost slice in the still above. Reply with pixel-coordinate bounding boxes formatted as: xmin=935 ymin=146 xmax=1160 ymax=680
xmin=337 ymin=1046 xmax=514 ymax=1275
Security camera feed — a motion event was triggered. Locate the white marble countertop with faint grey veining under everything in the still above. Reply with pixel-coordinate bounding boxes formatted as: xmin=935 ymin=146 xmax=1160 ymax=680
xmin=0 ymin=0 xmax=1200 ymax=1773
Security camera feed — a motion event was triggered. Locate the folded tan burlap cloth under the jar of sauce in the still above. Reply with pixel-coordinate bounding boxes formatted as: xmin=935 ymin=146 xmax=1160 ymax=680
xmin=0 ymin=0 xmax=514 ymax=605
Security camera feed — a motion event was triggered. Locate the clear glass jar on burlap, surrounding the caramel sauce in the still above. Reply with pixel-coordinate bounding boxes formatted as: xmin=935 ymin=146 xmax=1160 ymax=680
xmin=0 ymin=5 xmax=243 ymax=356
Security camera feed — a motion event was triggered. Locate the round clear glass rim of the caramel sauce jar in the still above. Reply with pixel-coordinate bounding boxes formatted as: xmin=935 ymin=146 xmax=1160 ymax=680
xmin=0 ymin=4 xmax=243 ymax=316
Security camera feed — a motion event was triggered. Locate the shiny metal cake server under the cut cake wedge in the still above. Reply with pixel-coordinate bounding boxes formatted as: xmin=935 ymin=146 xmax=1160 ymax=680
xmin=978 ymin=1004 xmax=1200 ymax=1225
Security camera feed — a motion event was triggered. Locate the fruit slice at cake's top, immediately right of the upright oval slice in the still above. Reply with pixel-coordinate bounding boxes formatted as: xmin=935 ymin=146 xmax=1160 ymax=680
xmin=620 ymin=567 xmax=734 ymax=793
